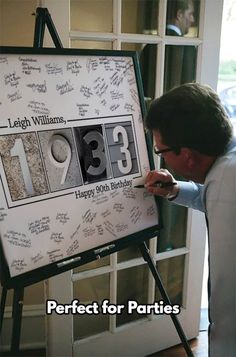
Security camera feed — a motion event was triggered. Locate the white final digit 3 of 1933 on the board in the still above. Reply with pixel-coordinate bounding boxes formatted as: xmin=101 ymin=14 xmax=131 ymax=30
xmin=113 ymin=125 xmax=132 ymax=175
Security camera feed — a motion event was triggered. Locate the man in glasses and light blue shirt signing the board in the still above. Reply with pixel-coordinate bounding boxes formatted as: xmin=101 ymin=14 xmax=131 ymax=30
xmin=146 ymin=83 xmax=236 ymax=357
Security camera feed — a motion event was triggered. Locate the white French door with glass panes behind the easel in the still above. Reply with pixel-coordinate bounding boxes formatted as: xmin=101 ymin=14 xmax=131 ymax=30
xmin=43 ymin=0 xmax=223 ymax=357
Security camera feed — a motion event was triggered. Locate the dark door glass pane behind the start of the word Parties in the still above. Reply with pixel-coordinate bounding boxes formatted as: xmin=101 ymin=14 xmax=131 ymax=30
xmin=116 ymin=265 xmax=148 ymax=326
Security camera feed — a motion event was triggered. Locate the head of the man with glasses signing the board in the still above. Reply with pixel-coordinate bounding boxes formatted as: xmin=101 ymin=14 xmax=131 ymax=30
xmin=146 ymin=83 xmax=233 ymax=182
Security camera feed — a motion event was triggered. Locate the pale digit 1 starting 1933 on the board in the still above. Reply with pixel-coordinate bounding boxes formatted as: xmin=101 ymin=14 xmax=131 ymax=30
xmin=11 ymin=138 xmax=35 ymax=195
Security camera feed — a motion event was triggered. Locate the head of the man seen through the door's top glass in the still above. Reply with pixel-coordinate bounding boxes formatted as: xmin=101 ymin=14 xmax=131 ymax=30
xmin=167 ymin=0 xmax=194 ymax=35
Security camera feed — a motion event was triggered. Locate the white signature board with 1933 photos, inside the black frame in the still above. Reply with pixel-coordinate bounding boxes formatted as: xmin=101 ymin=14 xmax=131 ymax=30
xmin=0 ymin=49 xmax=158 ymax=277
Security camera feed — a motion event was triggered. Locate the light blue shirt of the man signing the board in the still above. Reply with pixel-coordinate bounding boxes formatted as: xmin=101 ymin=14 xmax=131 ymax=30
xmin=172 ymin=139 xmax=236 ymax=357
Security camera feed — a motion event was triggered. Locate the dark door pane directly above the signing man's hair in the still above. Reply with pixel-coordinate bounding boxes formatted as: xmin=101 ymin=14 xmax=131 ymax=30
xmin=164 ymin=45 xmax=197 ymax=92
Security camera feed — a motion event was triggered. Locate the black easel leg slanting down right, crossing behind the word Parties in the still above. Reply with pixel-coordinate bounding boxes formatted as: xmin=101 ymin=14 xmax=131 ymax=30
xmin=139 ymin=242 xmax=193 ymax=357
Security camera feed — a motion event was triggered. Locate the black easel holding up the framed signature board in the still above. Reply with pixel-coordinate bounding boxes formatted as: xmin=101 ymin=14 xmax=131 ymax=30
xmin=0 ymin=8 xmax=193 ymax=357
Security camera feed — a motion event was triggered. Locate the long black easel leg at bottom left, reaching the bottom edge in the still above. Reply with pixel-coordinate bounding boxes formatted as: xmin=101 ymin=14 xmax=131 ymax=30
xmin=11 ymin=288 xmax=24 ymax=355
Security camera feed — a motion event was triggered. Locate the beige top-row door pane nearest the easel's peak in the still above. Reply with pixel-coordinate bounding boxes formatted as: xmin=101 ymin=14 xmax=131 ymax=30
xmin=70 ymin=0 xmax=113 ymax=32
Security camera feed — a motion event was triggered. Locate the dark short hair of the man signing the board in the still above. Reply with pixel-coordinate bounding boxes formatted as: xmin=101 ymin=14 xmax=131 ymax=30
xmin=146 ymin=83 xmax=233 ymax=156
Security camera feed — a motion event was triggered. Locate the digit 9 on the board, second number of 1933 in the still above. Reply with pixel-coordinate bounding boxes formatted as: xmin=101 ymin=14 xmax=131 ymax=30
xmin=48 ymin=134 xmax=71 ymax=185
